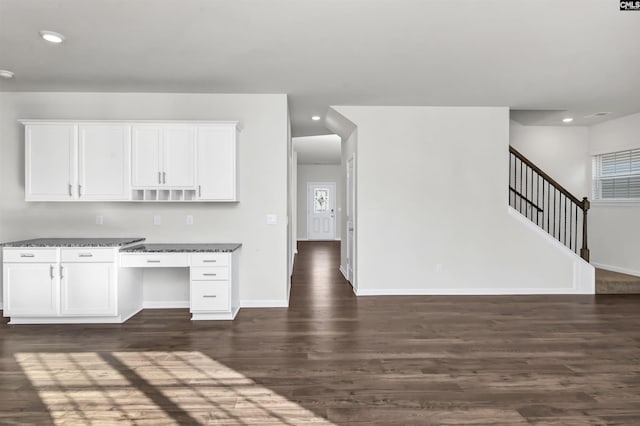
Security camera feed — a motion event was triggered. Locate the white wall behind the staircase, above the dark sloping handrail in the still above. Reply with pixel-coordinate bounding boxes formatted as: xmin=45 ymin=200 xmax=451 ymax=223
xmin=509 ymin=121 xmax=591 ymax=199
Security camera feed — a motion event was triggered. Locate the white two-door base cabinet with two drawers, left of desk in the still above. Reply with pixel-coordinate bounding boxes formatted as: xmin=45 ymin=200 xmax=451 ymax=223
xmin=3 ymin=248 xmax=121 ymax=323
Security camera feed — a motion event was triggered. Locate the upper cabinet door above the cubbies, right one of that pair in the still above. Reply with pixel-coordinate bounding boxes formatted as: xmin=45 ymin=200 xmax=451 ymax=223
xmin=162 ymin=126 xmax=195 ymax=187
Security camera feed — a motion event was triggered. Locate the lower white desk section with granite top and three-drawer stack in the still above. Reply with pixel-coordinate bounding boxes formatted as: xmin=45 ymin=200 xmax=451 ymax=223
xmin=120 ymin=244 xmax=241 ymax=320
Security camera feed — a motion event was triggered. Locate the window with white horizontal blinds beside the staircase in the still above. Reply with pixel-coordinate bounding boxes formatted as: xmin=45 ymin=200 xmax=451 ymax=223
xmin=592 ymin=149 xmax=640 ymax=201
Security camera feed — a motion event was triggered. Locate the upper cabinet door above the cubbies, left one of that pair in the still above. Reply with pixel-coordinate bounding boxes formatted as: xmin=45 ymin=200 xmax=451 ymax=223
xmin=131 ymin=126 xmax=162 ymax=187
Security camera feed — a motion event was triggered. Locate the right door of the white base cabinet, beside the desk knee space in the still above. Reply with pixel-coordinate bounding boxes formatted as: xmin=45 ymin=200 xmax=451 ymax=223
xmin=60 ymin=263 xmax=117 ymax=316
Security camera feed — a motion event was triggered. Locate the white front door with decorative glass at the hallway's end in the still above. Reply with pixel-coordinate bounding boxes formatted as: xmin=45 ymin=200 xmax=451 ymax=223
xmin=307 ymin=182 xmax=336 ymax=240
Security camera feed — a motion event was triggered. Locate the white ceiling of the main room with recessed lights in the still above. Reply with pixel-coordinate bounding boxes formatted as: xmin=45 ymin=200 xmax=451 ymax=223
xmin=0 ymin=0 xmax=640 ymax=136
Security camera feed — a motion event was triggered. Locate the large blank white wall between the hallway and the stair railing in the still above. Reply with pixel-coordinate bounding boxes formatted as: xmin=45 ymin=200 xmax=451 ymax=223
xmin=333 ymin=107 xmax=594 ymax=294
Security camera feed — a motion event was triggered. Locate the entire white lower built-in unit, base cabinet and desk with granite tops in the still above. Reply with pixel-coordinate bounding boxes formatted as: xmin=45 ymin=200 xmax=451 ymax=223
xmin=2 ymin=238 xmax=241 ymax=324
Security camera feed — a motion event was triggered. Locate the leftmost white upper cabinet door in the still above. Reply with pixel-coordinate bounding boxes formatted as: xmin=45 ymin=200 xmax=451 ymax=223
xmin=25 ymin=123 xmax=77 ymax=201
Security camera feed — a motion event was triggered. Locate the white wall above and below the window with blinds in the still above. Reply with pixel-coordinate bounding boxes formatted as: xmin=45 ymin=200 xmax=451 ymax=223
xmin=589 ymin=114 xmax=640 ymax=276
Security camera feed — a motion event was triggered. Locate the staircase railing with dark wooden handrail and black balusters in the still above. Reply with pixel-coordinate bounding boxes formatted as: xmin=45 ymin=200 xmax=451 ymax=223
xmin=509 ymin=146 xmax=589 ymax=262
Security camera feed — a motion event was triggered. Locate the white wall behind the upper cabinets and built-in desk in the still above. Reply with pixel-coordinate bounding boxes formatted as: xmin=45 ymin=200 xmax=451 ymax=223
xmin=0 ymin=93 xmax=288 ymax=304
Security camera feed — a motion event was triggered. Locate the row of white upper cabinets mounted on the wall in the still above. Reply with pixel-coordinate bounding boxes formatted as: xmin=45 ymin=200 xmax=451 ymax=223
xmin=19 ymin=120 xmax=240 ymax=202
